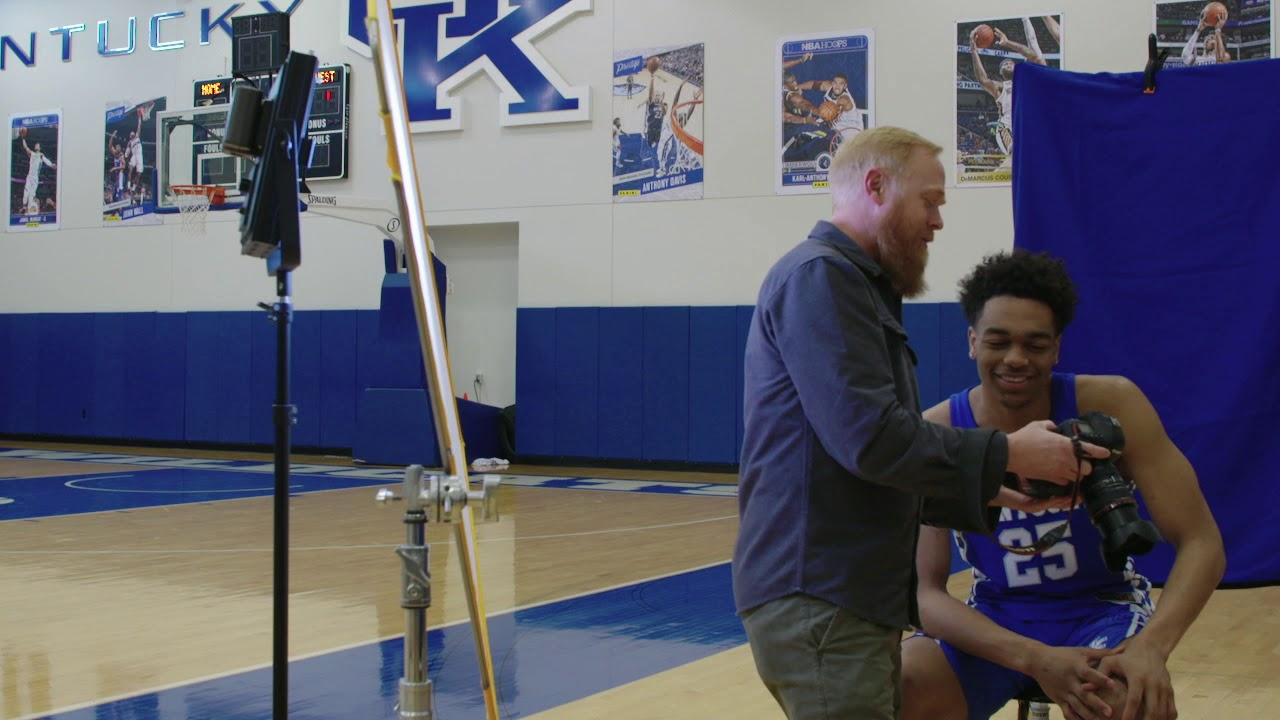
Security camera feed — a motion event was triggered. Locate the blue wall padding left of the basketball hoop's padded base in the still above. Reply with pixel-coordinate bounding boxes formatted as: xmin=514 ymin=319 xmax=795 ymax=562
xmin=0 ymin=310 xmax=360 ymax=447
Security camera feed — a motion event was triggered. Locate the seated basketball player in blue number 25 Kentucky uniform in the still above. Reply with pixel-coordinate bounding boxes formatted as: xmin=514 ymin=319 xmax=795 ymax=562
xmin=902 ymin=251 xmax=1225 ymax=720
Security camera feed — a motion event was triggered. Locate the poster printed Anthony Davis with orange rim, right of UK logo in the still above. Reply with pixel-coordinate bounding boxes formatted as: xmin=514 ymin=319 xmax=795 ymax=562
xmin=611 ymin=44 xmax=707 ymax=202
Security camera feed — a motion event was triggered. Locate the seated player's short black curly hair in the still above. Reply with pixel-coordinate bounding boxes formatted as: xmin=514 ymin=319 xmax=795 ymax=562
xmin=960 ymin=250 xmax=1079 ymax=334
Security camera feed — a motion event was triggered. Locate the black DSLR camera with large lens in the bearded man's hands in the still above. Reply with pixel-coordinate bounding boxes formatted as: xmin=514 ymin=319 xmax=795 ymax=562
xmin=1027 ymin=413 xmax=1164 ymax=573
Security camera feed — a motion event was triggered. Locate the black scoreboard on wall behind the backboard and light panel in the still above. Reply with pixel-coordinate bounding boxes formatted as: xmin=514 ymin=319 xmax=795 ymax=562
xmin=192 ymin=65 xmax=351 ymax=181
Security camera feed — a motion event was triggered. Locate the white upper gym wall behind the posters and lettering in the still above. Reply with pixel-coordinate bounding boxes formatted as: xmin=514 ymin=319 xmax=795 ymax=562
xmin=0 ymin=0 xmax=1198 ymax=313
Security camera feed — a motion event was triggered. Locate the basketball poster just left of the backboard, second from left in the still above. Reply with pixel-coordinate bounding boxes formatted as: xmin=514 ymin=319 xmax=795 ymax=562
xmin=102 ymin=97 xmax=165 ymax=227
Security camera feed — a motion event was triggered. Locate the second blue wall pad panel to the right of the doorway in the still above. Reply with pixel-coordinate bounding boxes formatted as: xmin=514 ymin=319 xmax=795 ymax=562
xmin=554 ymin=307 xmax=600 ymax=457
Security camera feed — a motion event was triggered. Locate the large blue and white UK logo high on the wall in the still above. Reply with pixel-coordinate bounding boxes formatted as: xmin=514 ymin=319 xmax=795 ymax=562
xmin=343 ymin=0 xmax=591 ymax=132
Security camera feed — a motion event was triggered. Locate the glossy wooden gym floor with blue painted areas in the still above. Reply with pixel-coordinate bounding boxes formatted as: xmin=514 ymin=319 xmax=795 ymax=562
xmin=0 ymin=442 xmax=1280 ymax=720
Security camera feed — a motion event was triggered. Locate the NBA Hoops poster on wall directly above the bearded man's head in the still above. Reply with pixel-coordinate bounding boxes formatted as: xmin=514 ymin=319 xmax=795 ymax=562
xmin=773 ymin=29 xmax=876 ymax=195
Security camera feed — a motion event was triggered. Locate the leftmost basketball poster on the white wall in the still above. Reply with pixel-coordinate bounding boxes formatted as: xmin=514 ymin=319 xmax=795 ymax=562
xmin=9 ymin=110 xmax=63 ymax=232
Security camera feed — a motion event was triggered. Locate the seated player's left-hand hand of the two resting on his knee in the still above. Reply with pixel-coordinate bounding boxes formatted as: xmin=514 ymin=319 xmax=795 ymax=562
xmin=1027 ymin=647 xmax=1124 ymax=720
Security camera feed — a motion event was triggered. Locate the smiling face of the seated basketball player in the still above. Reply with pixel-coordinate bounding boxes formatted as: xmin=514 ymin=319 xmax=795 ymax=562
xmin=969 ymin=295 xmax=1062 ymax=409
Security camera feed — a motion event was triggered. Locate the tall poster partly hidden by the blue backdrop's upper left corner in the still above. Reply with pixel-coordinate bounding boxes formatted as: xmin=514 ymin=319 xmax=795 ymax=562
xmin=955 ymin=14 xmax=1062 ymax=186
